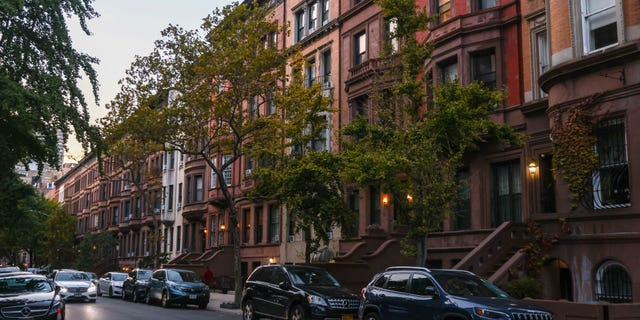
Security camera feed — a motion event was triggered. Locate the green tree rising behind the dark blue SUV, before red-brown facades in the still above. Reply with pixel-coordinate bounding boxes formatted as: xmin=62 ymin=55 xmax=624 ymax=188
xmin=343 ymin=0 xmax=521 ymax=266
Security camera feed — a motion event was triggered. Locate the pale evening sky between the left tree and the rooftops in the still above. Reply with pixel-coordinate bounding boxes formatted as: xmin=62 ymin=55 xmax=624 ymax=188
xmin=66 ymin=0 xmax=236 ymax=162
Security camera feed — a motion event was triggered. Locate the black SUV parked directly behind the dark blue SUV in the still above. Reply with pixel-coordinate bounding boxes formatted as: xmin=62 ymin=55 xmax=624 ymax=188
xmin=242 ymin=264 xmax=359 ymax=320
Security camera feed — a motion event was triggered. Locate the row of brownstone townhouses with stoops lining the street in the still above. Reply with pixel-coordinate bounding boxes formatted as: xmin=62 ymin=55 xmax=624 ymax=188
xmin=57 ymin=0 xmax=640 ymax=303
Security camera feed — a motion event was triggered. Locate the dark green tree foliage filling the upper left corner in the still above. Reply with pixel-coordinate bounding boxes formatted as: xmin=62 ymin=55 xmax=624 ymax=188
xmin=0 ymin=0 xmax=100 ymax=174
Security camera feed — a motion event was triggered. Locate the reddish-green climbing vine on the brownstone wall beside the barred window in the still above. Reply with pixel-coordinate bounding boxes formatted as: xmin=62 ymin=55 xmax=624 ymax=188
xmin=551 ymin=95 xmax=598 ymax=210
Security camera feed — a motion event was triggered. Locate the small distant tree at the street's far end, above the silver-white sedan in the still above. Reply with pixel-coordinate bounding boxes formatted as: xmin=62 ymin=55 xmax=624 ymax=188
xmin=40 ymin=202 xmax=76 ymax=269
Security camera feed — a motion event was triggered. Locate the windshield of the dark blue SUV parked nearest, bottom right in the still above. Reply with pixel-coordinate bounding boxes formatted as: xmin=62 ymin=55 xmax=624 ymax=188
xmin=433 ymin=273 xmax=508 ymax=298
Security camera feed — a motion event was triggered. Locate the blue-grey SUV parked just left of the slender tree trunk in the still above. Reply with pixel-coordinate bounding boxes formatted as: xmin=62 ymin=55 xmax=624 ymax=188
xmin=145 ymin=269 xmax=210 ymax=309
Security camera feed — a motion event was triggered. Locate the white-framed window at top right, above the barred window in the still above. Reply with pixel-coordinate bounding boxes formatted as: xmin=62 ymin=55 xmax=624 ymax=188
xmin=581 ymin=0 xmax=618 ymax=53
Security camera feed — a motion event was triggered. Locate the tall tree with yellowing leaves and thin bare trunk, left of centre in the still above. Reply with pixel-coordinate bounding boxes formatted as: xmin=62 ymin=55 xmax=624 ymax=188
xmin=103 ymin=3 xmax=328 ymax=304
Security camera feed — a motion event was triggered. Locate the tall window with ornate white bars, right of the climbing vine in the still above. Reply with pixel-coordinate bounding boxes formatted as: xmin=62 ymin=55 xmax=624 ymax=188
xmin=592 ymin=118 xmax=631 ymax=209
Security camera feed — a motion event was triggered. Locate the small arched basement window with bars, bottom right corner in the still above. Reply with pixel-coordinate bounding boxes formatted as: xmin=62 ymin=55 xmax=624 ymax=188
xmin=596 ymin=261 xmax=633 ymax=303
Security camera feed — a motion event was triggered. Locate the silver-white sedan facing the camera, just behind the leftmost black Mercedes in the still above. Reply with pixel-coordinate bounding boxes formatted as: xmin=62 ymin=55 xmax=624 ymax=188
xmin=51 ymin=269 xmax=96 ymax=302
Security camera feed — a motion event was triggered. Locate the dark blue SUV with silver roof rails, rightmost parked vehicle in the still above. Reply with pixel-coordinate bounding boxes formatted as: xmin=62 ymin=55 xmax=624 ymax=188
xmin=358 ymin=267 xmax=553 ymax=320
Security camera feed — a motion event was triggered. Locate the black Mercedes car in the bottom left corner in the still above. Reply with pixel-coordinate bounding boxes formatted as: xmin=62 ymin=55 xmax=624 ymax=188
xmin=0 ymin=272 xmax=65 ymax=320
